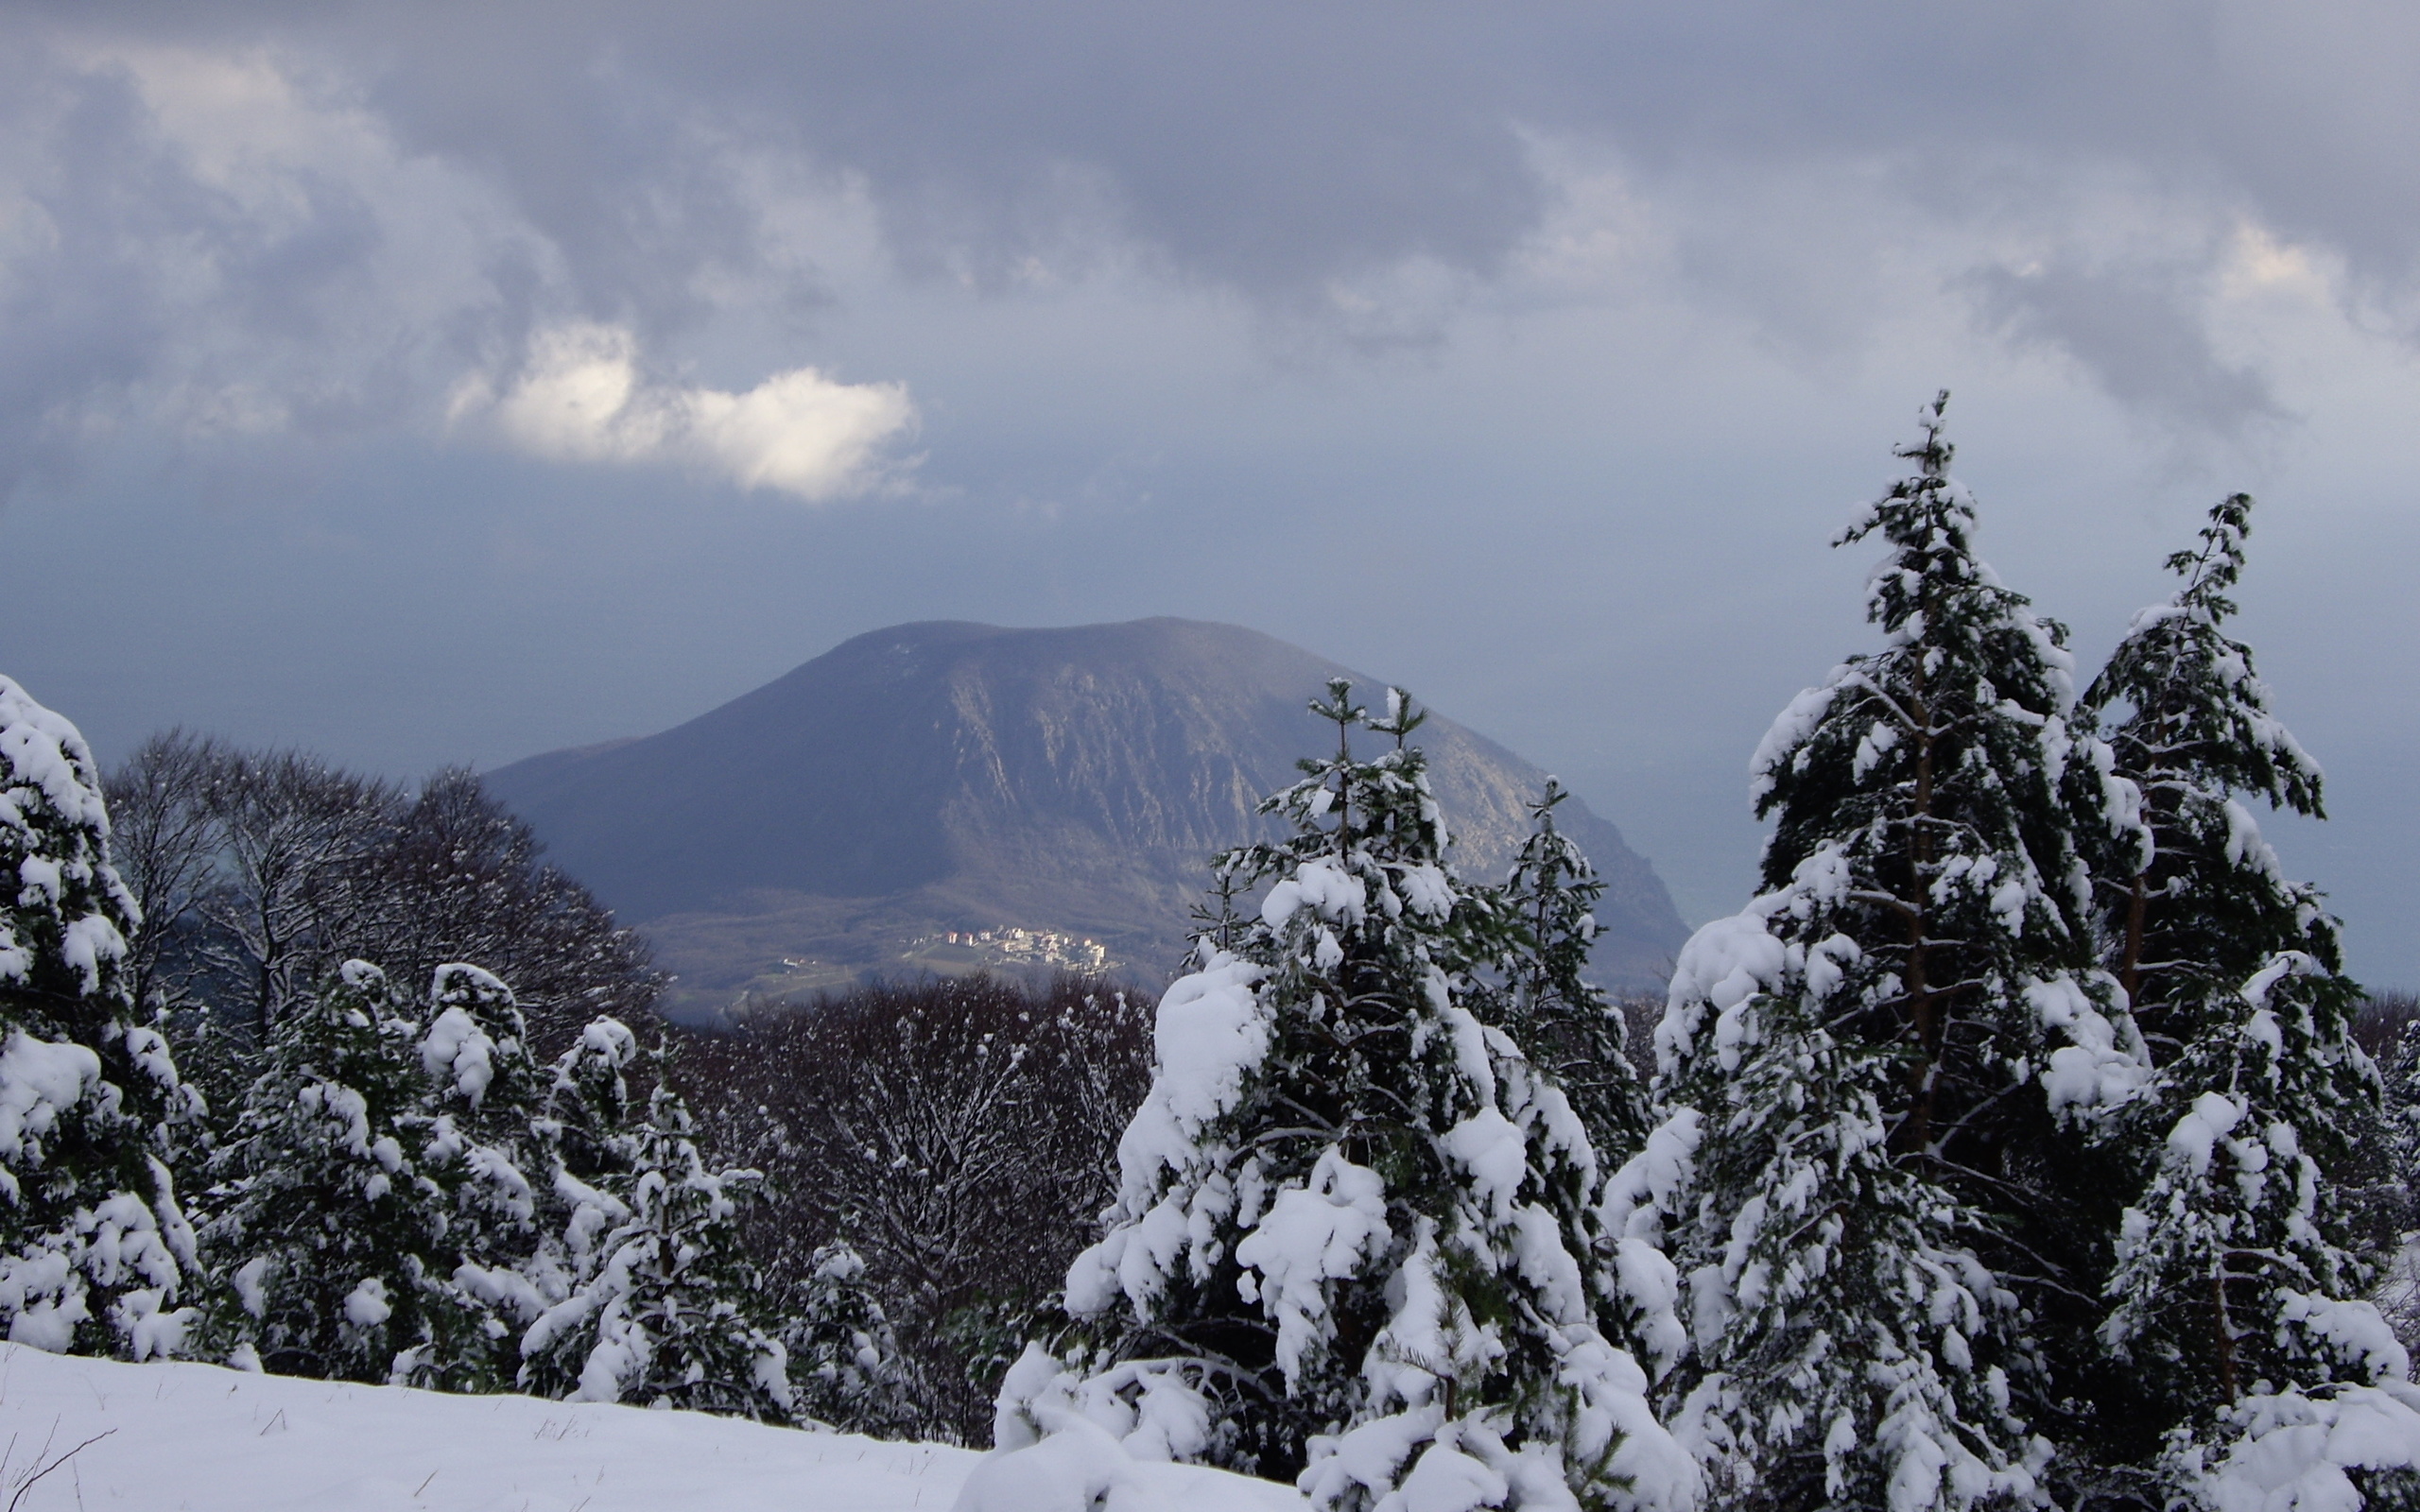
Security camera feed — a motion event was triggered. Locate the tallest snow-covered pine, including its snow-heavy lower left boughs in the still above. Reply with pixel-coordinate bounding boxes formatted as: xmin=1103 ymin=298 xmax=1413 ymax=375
xmin=1655 ymin=394 xmax=2142 ymax=1512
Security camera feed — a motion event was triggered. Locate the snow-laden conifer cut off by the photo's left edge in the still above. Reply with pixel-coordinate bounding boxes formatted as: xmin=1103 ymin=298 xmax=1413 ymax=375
xmin=0 ymin=678 xmax=200 ymax=1360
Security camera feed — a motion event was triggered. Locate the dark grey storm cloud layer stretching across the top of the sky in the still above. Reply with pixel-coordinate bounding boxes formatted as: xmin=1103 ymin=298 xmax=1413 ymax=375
xmin=14 ymin=3 xmax=2420 ymax=447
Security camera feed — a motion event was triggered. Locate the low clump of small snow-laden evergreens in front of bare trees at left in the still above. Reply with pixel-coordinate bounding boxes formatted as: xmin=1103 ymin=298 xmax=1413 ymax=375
xmin=208 ymin=960 xmax=898 ymax=1427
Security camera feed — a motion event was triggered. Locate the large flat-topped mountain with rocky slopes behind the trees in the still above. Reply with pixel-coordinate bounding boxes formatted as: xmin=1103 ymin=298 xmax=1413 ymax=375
xmin=487 ymin=619 xmax=1686 ymax=1011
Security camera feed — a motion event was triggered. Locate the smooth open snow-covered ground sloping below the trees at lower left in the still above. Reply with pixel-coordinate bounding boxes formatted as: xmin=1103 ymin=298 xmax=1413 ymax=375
xmin=0 ymin=1343 xmax=1300 ymax=1512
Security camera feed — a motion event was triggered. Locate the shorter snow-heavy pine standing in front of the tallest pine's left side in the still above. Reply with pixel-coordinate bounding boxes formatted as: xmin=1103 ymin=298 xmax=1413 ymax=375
xmin=1655 ymin=919 xmax=2043 ymax=1509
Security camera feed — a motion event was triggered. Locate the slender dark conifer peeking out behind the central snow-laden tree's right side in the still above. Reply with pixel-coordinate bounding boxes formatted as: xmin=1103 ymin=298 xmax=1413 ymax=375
xmin=1500 ymin=777 xmax=1648 ymax=1166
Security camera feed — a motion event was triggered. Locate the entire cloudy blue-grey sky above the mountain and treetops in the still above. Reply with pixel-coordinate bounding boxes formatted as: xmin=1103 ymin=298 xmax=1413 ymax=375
xmin=0 ymin=0 xmax=2420 ymax=987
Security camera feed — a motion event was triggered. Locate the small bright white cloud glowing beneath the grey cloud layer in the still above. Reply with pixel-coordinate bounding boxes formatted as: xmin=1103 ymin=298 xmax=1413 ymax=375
xmin=472 ymin=324 xmax=915 ymax=501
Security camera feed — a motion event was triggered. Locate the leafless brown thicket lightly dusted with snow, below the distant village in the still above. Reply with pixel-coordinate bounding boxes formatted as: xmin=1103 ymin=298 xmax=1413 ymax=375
xmin=683 ymin=977 xmax=1150 ymax=1442
